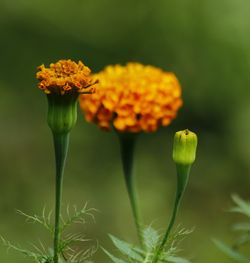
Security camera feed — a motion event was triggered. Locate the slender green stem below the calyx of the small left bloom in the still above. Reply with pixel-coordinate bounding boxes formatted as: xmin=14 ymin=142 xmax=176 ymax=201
xmin=53 ymin=133 xmax=69 ymax=263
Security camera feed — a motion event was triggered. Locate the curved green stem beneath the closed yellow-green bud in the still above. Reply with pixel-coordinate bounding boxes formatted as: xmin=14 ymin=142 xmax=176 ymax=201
xmin=152 ymin=165 xmax=191 ymax=263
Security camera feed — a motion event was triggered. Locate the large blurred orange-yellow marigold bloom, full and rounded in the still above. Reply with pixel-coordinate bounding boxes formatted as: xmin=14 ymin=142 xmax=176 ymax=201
xmin=80 ymin=63 xmax=182 ymax=132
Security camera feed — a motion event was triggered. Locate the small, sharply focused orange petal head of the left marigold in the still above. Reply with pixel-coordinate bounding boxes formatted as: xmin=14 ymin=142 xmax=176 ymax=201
xmin=36 ymin=59 xmax=96 ymax=95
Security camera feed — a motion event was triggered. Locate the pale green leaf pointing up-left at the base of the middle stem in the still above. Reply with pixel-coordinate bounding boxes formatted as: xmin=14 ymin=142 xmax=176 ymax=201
xmin=109 ymin=235 xmax=143 ymax=262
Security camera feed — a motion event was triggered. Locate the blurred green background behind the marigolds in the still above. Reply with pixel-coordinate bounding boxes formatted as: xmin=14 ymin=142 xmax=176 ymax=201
xmin=0 ymin=0 xmax=250 ymax=263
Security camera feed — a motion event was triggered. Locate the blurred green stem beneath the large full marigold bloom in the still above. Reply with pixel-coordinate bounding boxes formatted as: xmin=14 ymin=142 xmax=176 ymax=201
xmin=118 ymin=133 xmax=143 ymax=246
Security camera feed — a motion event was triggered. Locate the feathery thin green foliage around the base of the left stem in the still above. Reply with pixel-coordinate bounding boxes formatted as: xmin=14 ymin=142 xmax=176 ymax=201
xmin=1 ymin=204 xmax=98 ymax=263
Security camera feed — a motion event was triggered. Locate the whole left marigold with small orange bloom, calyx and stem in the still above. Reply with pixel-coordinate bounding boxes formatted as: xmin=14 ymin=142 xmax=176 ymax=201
xmin=36 ymin=59 xmax=96 ymax=263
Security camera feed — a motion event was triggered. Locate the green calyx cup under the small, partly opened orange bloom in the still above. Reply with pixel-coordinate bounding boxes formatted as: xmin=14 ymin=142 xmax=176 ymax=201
xmin=47 ymin=94 xmax=78 ymax=134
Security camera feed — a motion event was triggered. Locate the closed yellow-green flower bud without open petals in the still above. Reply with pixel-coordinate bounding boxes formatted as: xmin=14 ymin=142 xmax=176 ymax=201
xmin=173 ymin=129 xmax=198 ymax=165
